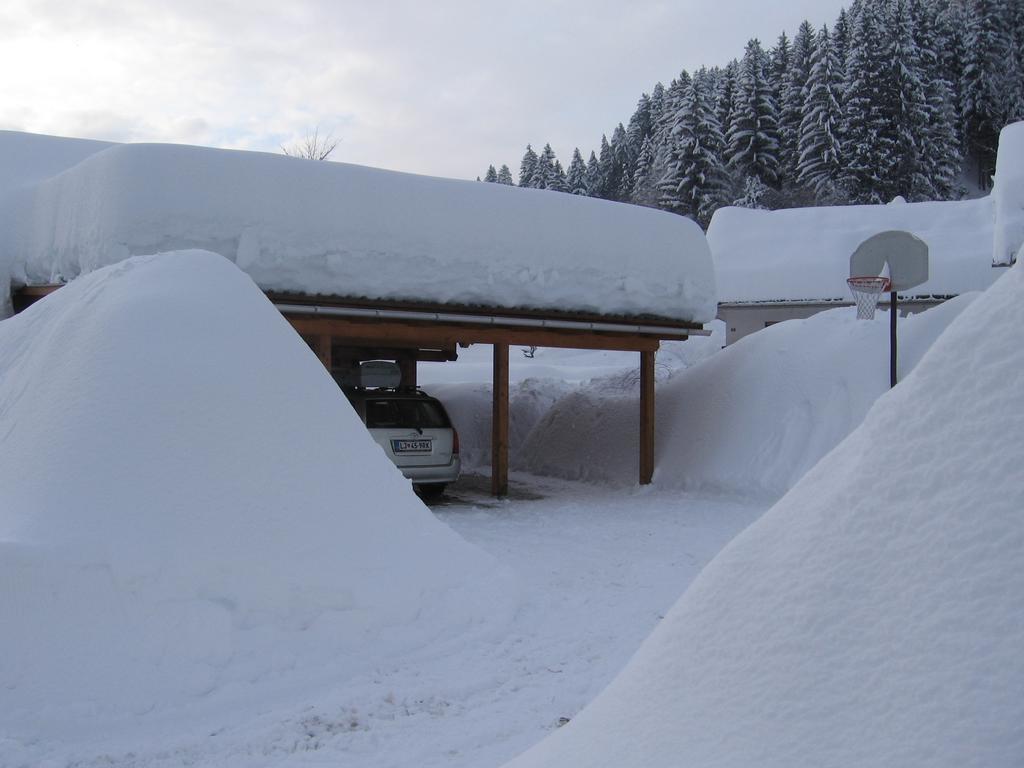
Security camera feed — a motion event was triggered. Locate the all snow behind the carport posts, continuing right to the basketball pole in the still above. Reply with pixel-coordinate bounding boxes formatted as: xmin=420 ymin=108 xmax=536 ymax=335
xmin=422 ymin=301 xmax=978 ymax=498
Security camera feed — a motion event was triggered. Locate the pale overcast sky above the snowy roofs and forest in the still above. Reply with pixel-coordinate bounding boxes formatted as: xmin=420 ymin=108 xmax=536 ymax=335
xmin=0 ymin=0 xmax=848 ymax=178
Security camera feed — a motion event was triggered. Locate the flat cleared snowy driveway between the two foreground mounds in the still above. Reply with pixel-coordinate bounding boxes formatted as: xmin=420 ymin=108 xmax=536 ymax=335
xmin=0 ymin=475 xmax=764 ymax=768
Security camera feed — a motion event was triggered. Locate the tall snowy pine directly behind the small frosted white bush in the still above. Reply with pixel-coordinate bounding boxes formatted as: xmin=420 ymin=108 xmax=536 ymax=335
xmin=726 ymin=39 xmax=779 ymax=185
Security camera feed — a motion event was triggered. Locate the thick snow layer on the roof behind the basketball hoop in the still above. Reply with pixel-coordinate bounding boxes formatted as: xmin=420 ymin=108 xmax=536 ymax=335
xmin=708 ymin=198 xmax=999 ymax=303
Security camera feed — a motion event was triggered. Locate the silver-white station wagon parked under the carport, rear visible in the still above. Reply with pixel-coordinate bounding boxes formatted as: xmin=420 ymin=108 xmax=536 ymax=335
xmin=345 ymin=389 xmax=462 ymax=497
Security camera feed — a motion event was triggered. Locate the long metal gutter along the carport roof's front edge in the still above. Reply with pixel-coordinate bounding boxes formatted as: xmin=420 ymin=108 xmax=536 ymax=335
xmin=274 ymin=303 xmax=711 ymax=337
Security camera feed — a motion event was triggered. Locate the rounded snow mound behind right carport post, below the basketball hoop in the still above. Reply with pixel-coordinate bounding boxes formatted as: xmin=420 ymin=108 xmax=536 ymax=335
xmin=517 ymin=294 xmax=977 ymax=498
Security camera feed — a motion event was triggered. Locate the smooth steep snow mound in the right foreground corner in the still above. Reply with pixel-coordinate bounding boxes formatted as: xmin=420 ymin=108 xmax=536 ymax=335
xmin=510 ymin=267 xmax=1024 ymax=768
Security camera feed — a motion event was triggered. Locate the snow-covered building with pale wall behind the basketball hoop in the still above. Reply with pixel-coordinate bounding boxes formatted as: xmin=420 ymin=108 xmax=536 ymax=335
xmin=708 ymin=123 xmax=1024 ymax=344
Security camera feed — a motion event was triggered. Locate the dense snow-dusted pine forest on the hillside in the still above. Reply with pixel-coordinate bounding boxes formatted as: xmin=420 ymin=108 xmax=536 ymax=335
xmin=484 ymin=0 xmax=1024 ymax=226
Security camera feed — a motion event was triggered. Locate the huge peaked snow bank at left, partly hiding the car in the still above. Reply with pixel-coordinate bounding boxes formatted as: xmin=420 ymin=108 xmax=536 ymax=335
xmin=0 ymin=252 xmax=510 ymax=745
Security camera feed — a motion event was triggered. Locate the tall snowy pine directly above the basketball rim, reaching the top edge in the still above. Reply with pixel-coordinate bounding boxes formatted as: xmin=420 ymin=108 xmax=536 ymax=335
xmin=842 ymin=0 xmax=896 ymax=203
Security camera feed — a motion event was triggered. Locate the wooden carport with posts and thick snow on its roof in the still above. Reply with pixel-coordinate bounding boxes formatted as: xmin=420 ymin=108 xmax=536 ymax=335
xmin=0 ymin=132 xmax=717 ymax=489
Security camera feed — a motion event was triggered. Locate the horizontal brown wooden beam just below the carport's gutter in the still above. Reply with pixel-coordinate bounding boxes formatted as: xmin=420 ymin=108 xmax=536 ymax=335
xmin=285 ymin=314 xmax=663 ymax=352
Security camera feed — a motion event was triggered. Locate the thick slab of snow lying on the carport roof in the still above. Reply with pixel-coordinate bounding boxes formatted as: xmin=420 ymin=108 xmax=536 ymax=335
xmin=0 ymin=133 xmax=716 ymax=323
